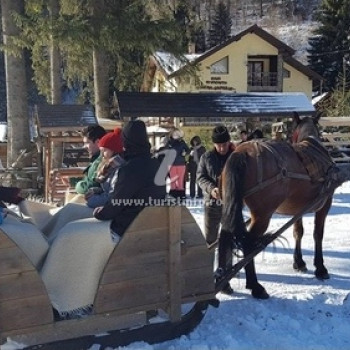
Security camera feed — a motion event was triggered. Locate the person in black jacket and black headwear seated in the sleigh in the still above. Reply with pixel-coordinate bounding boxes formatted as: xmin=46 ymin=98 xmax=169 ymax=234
xmin=94 ymin=120 xmax=166 ymax=236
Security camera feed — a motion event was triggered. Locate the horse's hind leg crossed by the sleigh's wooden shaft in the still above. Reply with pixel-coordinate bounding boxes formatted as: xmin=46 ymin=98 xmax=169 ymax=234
xmin=243 ymin=215 xmax=270 ymax=299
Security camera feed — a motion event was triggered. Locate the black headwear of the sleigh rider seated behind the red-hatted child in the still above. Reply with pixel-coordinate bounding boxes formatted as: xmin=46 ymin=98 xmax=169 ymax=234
xmin=123 ymin=120 xmax=151 ymax=153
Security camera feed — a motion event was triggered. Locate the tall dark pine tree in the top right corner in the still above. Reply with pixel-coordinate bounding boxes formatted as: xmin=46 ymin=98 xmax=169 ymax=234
xmin=308 ymin=0 xmax=350 ymax=91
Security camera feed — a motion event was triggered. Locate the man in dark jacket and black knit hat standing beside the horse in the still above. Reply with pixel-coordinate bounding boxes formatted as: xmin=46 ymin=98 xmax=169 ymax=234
xmin=197 ymin=125 xmax=234 ymax=294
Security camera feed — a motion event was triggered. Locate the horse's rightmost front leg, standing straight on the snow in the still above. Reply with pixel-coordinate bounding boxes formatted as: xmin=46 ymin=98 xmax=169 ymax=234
xmin=314 ymin=197 xmax=332 ymax=280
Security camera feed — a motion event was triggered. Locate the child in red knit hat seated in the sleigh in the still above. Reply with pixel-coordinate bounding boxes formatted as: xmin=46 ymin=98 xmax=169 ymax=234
xmin=85 ymin=128 xmax=125 ymax=208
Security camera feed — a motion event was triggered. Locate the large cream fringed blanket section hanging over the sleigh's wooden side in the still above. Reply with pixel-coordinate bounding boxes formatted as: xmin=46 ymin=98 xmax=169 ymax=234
xmin=41 ymin=218 xmax=117 ymax=317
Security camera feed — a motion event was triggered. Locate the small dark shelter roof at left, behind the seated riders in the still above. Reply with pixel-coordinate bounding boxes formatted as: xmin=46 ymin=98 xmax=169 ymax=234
xmin=35 ymin=105 xmax=98 ymax=132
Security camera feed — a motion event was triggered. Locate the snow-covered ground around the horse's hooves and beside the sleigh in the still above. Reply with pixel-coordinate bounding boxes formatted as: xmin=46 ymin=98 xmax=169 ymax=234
xmin=113 ymin=182 xmax=350 ymax=350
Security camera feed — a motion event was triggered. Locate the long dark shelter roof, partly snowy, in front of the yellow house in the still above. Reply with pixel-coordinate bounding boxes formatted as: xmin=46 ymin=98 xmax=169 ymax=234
xmin=117 ymin=92 xmax=315 ymax=118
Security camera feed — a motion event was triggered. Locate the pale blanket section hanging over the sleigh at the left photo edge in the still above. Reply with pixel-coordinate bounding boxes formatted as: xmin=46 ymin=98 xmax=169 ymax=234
xmin=0 ymin=214 xmax=49 ymax=268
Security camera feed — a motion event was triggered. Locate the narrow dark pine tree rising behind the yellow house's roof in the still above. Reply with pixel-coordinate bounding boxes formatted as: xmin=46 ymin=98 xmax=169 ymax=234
xmin=209 ymin=1 xmax=232 ymax=47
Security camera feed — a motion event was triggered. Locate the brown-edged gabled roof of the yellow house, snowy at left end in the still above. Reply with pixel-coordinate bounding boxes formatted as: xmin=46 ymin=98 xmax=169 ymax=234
xmin=153 ymin=24 xmax=323 ymax=80
